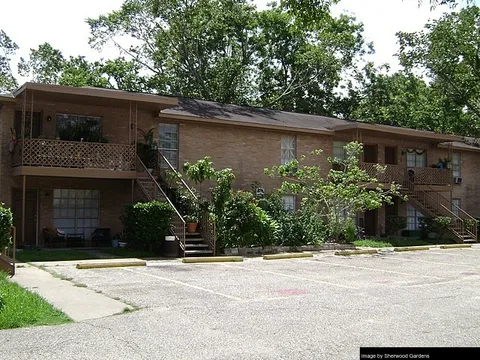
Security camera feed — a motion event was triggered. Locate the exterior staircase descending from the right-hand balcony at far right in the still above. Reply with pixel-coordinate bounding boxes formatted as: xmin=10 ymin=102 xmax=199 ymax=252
xmin=396 ymin=172 xmax=477 ymax=243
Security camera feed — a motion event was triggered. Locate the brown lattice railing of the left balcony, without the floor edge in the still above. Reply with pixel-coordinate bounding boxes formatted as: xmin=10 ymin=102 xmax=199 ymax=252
xmin=12 ymin=139 xmax=136 ymax=171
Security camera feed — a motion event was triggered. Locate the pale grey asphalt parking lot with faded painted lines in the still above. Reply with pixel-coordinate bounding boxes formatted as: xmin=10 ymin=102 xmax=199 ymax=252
xmin=0 ymin=245 xmax=480 ymax=359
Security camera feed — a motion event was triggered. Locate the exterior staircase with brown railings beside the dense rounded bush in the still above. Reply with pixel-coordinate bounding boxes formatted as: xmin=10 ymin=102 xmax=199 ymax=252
xmin=136 ymin=152 xmax=216 ymax=257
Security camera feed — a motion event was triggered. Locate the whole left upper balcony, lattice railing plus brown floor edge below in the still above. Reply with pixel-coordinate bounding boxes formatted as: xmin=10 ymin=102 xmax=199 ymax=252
xmin=12 ymin=139 xmax=136 ymax=179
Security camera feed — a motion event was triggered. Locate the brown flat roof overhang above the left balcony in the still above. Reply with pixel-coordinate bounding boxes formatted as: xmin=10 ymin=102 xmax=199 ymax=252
xmin=13 ymin=82 xmax=178 ymax=110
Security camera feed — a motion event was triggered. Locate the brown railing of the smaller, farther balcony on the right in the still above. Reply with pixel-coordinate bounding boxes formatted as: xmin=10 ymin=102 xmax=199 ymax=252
xmin=360 ymin=163 xmax=453 ymax=186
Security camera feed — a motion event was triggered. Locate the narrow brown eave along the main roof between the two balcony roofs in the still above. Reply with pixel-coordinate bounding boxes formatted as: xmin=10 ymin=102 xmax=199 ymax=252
xmin=158 ymin=112 xmax=335 ymax=136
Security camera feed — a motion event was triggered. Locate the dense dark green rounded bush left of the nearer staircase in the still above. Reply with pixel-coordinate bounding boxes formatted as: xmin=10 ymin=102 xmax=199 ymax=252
xmin=121 ymin=201 xmax=174 ymax=252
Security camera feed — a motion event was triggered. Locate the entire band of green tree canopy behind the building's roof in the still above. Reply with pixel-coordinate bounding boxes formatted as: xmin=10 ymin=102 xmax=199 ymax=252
xmin=0 ymin=0 xmax=480 ymax=136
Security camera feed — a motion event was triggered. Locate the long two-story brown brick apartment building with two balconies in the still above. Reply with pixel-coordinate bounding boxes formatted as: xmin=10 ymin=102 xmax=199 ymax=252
xmin=0 ymin=83 xmax=480 ymax=250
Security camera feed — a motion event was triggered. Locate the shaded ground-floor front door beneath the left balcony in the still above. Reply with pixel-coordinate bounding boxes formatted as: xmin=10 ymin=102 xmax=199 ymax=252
xmin=12 ymin=189 xmax=37 ymax=245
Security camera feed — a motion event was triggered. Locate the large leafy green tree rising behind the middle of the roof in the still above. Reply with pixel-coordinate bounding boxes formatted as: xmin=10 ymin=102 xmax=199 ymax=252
xmin=88 ymin=0 xmax=368 ymax=114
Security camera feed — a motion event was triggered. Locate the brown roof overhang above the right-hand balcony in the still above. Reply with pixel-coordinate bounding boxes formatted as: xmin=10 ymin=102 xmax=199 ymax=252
xmin=331 ymin=122 xmax=462 ymax=141
